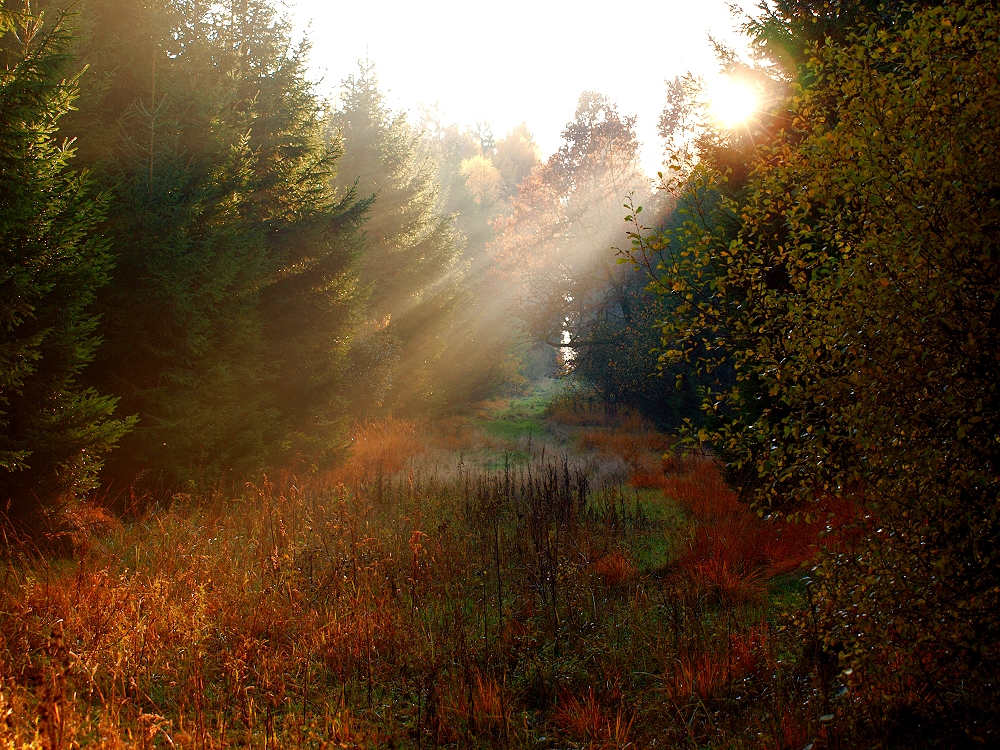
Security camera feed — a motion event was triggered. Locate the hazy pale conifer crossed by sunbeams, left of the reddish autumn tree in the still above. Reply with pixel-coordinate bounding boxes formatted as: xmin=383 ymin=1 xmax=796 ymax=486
xmin=330 ymin=64 xmax=466 ymax=411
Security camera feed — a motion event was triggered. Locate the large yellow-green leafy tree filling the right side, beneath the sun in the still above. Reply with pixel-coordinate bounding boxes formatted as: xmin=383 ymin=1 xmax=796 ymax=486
xmin=634 ymin=2 xmax=1000 ymax=746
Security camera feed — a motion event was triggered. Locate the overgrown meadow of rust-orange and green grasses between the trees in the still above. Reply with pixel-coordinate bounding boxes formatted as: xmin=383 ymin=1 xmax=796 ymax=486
xmin=0 ymin=393 xmax=863 ymax=750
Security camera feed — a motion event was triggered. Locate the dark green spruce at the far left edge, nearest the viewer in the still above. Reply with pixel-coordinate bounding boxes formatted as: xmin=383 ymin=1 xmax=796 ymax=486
xmin=0 ymin=5 xmax=131 ymax=523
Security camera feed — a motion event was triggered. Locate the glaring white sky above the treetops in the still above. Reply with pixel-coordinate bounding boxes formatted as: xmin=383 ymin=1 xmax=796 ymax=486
xmin=286 ymin=0 xmax=756 ymax=174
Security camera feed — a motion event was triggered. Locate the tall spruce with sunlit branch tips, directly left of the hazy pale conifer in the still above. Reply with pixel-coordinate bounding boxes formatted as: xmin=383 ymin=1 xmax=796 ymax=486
xmin=204 ymin=0 xmax=370 ymax=468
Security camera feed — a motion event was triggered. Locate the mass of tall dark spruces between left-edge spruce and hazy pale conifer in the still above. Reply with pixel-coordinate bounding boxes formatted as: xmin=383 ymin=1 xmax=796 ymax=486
xmin=61 ymin=0 xmax=366 ymax=488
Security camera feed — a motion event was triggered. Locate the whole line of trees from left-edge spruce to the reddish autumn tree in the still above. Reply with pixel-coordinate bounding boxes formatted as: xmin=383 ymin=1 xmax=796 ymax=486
xmin=0 ymin=0 xmax=697 ymax=525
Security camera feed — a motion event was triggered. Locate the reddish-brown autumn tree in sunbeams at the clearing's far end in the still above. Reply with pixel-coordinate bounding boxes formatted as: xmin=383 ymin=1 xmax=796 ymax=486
xmin=492 ymin=93 xmax=648 ymax=374
